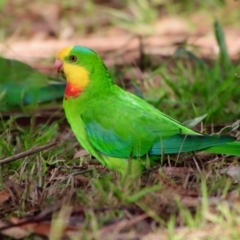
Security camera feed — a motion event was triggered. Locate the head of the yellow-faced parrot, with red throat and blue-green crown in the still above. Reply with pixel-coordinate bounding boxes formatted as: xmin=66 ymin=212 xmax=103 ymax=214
xmin=54 ymin=46 xmax=109 ymax=99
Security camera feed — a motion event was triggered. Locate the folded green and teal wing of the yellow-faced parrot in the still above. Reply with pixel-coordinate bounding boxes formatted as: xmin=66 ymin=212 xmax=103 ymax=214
xmin=81 ymin=87 xmax=235 ymax=158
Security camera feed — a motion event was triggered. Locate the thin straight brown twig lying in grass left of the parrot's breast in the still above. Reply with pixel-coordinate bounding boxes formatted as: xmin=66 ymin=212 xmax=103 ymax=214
xmin=0 ymin=142 xmax=57 ymax=165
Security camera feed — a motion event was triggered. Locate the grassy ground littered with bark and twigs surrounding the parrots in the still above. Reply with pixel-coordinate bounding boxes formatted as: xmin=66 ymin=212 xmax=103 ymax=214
xmin=0 ymin=0 xmax=240 ymax=240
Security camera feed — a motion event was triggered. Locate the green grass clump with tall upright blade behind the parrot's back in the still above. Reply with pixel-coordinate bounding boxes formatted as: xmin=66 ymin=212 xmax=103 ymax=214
xmin=138 ymin=22 xmax=240 ymax=124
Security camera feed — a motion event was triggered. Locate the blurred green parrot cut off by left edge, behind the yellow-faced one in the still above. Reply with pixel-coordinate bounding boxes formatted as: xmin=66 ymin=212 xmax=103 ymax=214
xmin=0 ymin=57 xmax=66 ymax=113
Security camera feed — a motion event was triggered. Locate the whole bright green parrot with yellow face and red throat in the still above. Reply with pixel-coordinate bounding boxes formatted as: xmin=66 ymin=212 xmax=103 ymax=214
xmin=54 ymin=46 xmax=240 ymax=174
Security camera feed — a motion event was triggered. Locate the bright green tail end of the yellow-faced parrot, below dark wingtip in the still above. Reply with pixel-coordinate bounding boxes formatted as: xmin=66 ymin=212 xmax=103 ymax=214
xmin=203 ymin=142 xmax=240 ymax=156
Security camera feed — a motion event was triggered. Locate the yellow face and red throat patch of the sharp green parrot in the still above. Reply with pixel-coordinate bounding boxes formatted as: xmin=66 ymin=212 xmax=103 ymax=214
xmin=55 ymin=47 xmax=89 ymax=99
